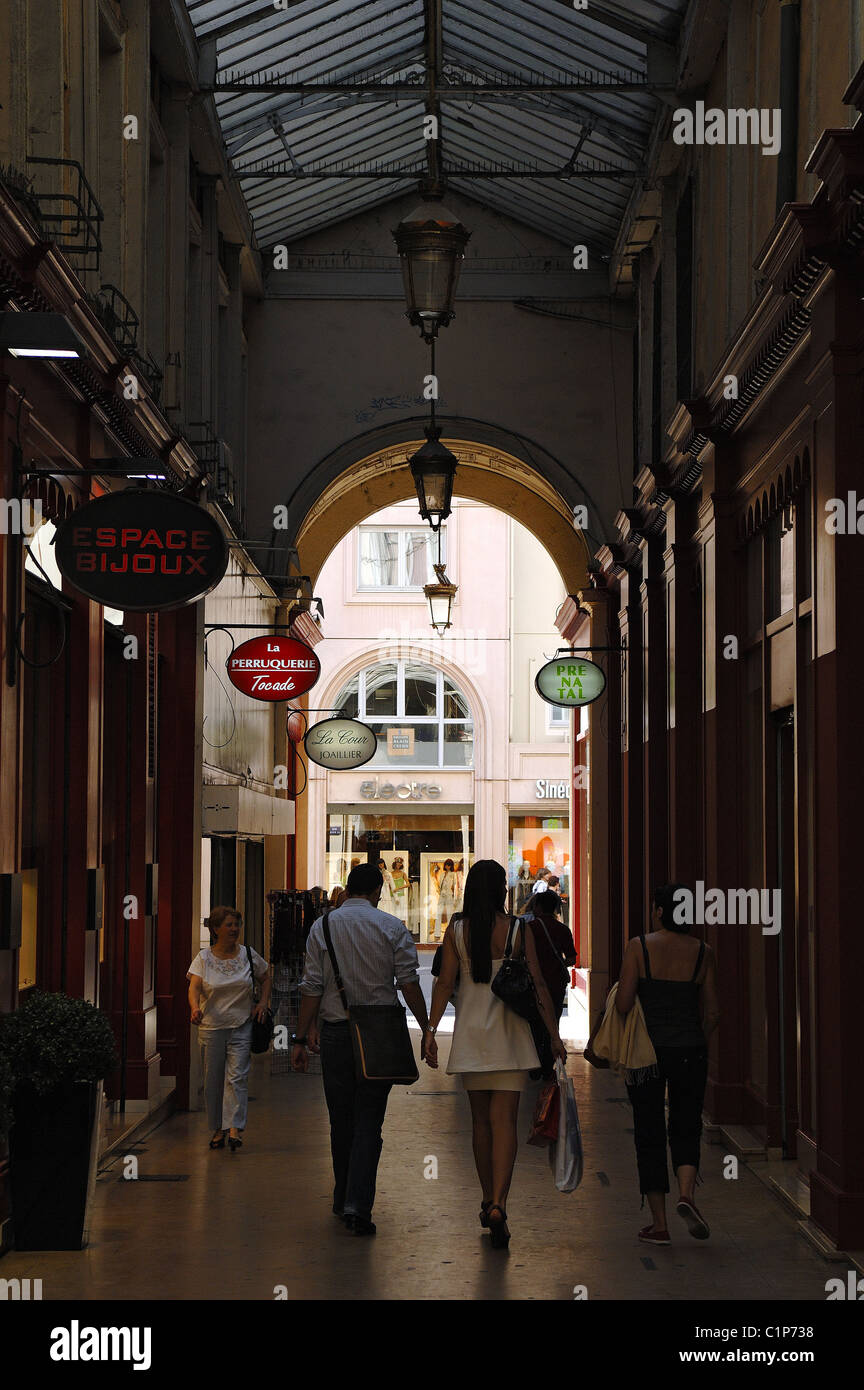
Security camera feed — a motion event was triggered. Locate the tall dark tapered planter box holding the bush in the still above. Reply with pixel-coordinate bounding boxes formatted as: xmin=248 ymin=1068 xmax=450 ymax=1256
xmin=10 ymin=1081 xmax=101 ymax=1250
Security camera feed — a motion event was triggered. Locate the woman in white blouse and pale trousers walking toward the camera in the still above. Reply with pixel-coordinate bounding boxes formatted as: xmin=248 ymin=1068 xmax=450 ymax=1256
xmin=188 ymin=908 xmax=271 ymax=1151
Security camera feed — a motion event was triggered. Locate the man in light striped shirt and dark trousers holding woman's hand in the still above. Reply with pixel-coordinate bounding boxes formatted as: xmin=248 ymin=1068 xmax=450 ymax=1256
xmin=293 ymin=865 xmax=429 ymax=1236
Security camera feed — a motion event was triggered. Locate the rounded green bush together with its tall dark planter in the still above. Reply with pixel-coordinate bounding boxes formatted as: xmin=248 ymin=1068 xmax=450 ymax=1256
xmin=0 ymin=990 xmax=117 ymax=1250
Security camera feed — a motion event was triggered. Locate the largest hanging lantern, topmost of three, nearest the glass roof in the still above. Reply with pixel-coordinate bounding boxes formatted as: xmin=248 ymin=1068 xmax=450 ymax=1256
xmin=393 ymin=200 xmax=471 ymax=342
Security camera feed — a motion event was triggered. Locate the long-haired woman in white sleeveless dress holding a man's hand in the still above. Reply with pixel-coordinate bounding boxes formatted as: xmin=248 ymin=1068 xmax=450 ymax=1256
xmin=424 ymin=859 xmax=567 ymax=1248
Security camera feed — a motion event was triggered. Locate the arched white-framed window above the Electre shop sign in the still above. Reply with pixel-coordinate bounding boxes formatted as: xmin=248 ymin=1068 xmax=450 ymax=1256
xmin=333 ymin=660 xmax=474 ymax=769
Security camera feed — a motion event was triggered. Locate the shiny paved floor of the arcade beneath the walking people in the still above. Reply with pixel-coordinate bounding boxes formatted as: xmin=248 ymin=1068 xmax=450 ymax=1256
xmin=0 ymin=1038 xmax=836 ymax=1301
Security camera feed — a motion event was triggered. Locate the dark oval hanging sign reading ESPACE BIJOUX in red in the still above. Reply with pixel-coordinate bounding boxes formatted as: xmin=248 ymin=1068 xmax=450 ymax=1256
xmin=54 ymin=488 xmax=228 ymax=613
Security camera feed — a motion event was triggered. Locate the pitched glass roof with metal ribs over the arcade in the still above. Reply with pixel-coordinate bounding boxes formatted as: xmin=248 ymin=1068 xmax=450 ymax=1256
xmin=188 ymin=0 xmax=688 ymax=254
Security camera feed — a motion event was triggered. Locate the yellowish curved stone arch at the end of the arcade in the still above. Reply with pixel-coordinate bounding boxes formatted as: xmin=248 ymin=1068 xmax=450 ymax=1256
xmin=291 ymin=427 xmax=600 ymax=594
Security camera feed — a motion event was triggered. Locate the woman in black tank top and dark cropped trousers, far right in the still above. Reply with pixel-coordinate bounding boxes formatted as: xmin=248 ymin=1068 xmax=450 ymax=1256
xmin=615 ymin=884 xmax=720 ymax=1245
